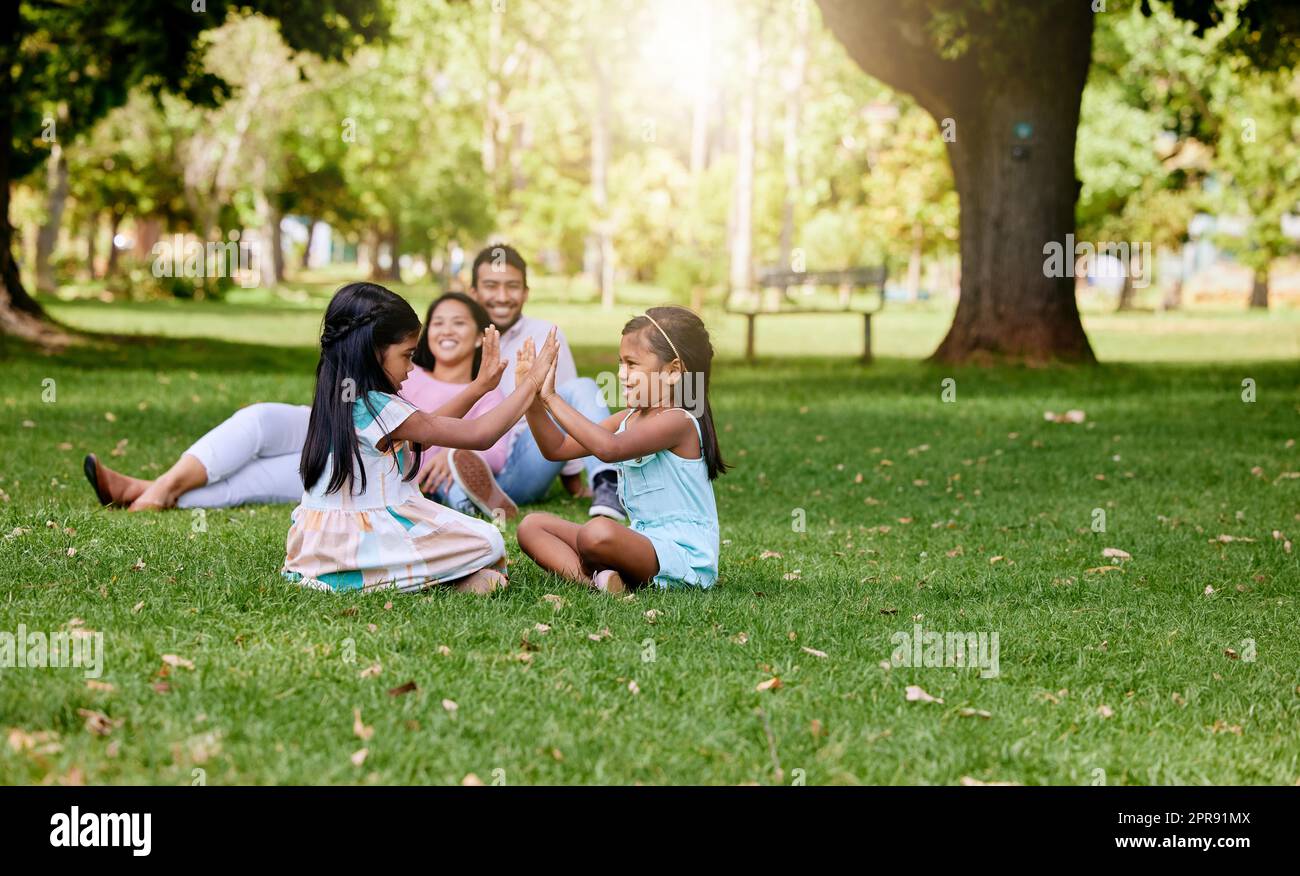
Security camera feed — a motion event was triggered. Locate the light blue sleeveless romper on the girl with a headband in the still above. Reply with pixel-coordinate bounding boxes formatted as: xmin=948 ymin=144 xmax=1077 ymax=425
xmin=615 ymin=408 xmax=718 ymax=587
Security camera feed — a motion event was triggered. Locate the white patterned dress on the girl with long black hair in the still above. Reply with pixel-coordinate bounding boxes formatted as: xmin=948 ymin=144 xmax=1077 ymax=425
xmin=282 ymin=391 xmax=506 ymax=590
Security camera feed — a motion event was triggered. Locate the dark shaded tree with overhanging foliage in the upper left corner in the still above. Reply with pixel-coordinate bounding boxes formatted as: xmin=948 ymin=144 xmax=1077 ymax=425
xmin=0 ymin=0 xmax=386 ymax=341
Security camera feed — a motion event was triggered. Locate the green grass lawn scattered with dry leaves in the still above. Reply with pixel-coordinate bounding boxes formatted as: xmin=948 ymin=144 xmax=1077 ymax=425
xmin=0 ymin=302 xmax=1300 ymax=784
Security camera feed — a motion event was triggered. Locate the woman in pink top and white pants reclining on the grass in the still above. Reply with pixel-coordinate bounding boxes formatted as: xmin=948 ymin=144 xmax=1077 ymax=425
xmin=83 ymin=292 xmax=519 ymax=520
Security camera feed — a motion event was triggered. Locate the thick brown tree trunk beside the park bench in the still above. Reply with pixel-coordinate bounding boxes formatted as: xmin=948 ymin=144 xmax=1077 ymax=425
xmin=818 ymin=0 xmax=1095 ymax=363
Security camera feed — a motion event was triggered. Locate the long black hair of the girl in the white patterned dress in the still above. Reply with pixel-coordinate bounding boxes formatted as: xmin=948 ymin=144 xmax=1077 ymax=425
xmin=298 ymin=283 xmax=421 ymax=494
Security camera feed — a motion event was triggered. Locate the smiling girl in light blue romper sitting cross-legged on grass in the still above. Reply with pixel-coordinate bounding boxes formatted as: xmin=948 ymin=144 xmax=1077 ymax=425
xmin=517 ymin=307 xmax=728 ymax=593
